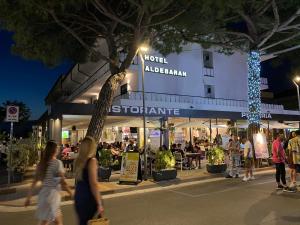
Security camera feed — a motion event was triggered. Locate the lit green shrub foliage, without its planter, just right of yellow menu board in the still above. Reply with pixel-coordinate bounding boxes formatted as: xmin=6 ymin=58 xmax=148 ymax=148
xmin=155 ymin=150 xmax=175 ymax=171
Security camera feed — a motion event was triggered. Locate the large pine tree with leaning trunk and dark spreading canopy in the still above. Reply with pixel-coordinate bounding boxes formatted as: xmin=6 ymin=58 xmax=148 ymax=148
xmin=0 ymin=0 xmax=193 ymax=139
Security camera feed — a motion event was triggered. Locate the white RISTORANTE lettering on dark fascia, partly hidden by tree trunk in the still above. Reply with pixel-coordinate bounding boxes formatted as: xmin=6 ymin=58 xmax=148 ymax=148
xmin=109 ymin=105 xmax=180 ymax=116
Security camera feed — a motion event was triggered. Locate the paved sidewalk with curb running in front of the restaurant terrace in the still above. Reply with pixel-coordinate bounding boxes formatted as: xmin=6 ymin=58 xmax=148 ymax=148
xmin=0 ymin=163 xmax=274 ymax=207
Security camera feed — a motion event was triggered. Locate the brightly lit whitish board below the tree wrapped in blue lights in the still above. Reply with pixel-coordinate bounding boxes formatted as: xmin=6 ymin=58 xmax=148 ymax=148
xmin=253 ymin=133 xmax=269 ymax=159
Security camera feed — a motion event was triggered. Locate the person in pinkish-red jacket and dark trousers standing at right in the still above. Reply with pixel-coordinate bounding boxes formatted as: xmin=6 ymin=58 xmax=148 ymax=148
xmin=272 ymin=134 xmax=288 ymax=190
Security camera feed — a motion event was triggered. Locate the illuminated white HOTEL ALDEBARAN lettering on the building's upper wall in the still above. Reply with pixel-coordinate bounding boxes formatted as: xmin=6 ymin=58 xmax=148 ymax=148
xmin=144 ymin=55 xmax=187 ymax=77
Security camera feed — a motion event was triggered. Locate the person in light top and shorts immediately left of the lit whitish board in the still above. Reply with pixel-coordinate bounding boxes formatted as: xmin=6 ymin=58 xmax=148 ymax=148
xmin=242 ymin=137 xmax=255 ymax=182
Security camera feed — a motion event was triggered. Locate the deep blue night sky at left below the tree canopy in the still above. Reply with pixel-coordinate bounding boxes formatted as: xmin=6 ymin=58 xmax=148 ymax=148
xmin=0 ymin=30 xmax=71 ymax=119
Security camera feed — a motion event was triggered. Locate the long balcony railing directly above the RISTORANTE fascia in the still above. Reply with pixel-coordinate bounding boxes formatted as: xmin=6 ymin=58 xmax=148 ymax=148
xmin=115 ymin=91 xmax=284 ymax=110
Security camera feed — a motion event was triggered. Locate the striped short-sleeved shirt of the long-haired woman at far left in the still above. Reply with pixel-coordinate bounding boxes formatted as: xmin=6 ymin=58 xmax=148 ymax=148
xmin=43 ymin=159 xmax=64 ymax=188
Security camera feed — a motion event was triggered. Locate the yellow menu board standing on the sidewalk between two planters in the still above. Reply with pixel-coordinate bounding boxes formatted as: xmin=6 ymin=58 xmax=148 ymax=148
xmin=120 ymin=152 xmax=139 ymax=182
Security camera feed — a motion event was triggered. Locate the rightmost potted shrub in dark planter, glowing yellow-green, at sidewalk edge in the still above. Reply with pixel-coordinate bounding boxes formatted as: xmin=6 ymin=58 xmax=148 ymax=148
xmin=206 ymin=147 xmax=227 ymax=173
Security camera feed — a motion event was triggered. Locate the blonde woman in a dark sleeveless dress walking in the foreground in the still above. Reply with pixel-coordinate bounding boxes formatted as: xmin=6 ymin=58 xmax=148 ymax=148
xmin=75 ymin=136 xmax=104 ymax=225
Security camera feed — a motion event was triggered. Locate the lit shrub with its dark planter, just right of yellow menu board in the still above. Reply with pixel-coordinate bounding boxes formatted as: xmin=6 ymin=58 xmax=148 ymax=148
xmin=152 ymin=150 xmax=177 ymax=181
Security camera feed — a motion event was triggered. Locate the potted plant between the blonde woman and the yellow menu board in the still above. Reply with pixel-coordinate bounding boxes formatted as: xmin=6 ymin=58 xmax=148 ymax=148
xmin=98 ymin=149 xmax=112 ymax=181
